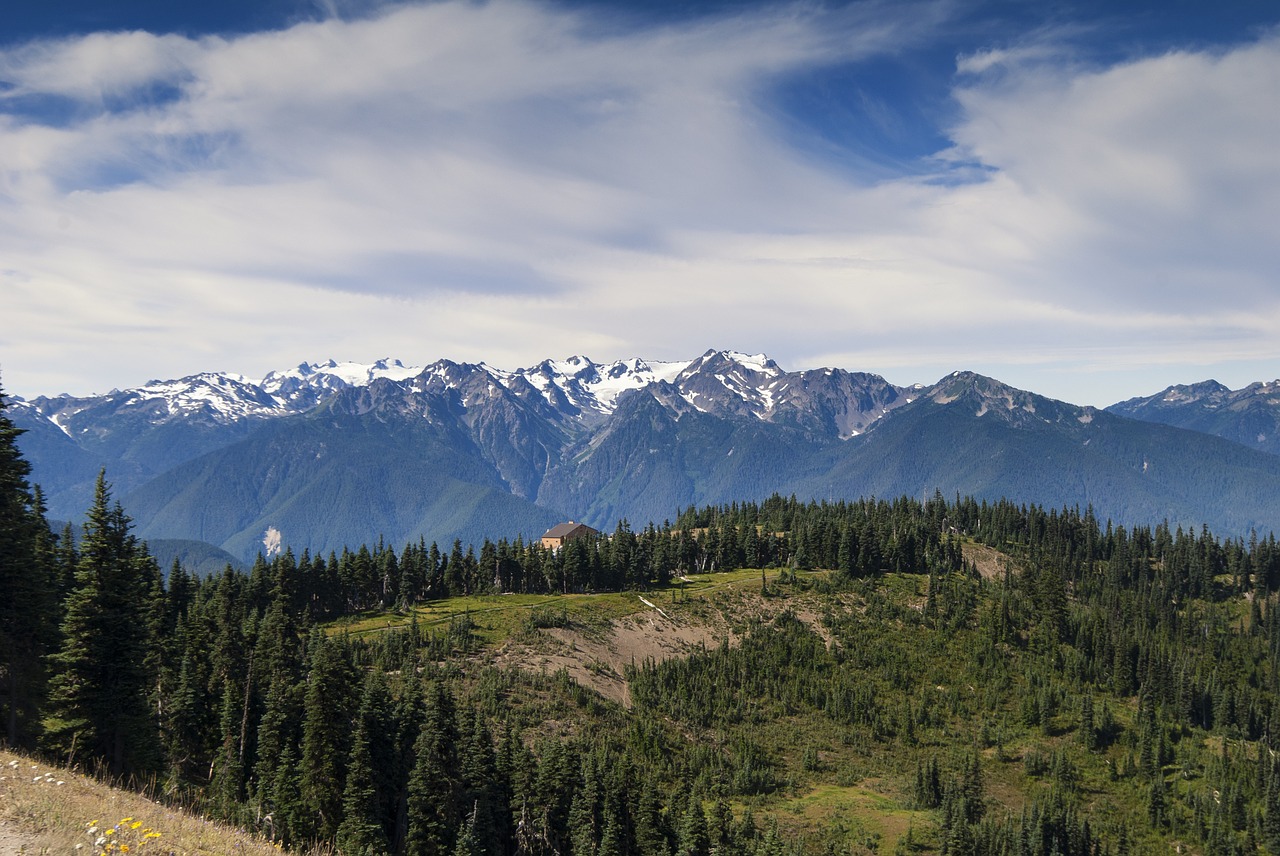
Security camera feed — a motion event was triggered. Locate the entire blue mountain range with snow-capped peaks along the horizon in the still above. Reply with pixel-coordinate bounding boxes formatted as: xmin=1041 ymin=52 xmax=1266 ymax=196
xmin=6 ymin=351 xmax=1280 ymax=559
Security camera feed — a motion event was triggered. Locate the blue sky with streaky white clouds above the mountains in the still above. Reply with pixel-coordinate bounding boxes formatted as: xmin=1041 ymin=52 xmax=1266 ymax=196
xmin=0 ymin=0 xmax=1280 ymax=407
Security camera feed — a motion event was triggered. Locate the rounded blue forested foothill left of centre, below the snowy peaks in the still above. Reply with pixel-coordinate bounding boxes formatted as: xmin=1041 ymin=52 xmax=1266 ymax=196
xmin=123 ymin=401 xmax=559 ymax=558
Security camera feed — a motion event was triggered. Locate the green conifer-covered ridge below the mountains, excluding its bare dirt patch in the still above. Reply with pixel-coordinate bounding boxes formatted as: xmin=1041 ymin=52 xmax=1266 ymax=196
xmin=0 ymin=386 xmax=1280 ymax=856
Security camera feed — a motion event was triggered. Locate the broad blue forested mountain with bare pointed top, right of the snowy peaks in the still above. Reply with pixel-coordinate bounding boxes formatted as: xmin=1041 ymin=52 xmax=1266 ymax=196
xmin=800 ymin=372 xmax=1280 ymax=534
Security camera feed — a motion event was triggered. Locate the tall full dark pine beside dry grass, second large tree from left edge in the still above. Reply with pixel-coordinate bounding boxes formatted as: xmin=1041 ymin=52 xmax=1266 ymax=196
xmin=49 ymin=473 xmax=159 ymax=775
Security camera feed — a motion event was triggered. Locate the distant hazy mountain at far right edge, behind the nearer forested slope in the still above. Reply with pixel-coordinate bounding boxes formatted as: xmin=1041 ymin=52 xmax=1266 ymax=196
xmin=1107 ymin=380 xmax=1280 ymax=454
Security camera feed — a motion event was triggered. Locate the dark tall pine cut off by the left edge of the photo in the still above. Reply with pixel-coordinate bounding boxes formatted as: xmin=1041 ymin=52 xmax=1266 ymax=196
xmin=0 ymin=381 xmax=58 ymax=749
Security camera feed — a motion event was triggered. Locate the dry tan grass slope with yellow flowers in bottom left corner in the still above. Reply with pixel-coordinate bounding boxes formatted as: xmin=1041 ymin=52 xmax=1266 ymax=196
xmin=0 ymin=750 xmax=304 ymax=856
